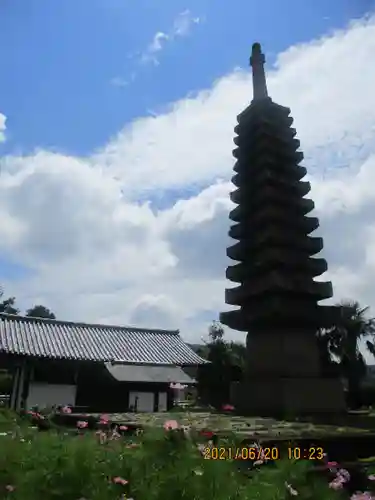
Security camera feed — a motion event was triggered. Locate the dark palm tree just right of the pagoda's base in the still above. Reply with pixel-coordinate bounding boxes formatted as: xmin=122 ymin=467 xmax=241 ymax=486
xmin=326 ymin=301 xmax=375 ymax=409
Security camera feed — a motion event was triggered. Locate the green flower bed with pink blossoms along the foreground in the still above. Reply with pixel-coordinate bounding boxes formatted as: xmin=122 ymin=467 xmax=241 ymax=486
xmin=0 ymin=412 xmax=375 ymax=500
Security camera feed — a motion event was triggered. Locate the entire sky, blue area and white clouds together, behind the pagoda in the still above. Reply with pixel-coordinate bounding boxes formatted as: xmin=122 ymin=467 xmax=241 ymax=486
xmin=0 ymin=0 xmax=375 ymax=341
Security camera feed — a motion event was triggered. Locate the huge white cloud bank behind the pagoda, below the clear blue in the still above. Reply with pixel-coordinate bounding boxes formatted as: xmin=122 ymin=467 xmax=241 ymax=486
xmin=0 ymin=14 xmax=375 ymax=364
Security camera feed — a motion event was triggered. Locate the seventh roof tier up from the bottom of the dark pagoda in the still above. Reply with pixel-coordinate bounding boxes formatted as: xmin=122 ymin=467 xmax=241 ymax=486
xmin=229 ymin=181 xmax=311 ymax=204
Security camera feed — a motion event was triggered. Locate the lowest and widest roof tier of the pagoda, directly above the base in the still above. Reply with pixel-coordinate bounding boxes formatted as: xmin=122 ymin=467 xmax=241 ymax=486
xmin=220 ymin=304 xmax=339 ymax=334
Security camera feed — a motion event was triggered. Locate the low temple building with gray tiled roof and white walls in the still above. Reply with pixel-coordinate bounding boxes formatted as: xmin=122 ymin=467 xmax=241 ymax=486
xmin=0 ymin=314 xmax=206 ymax=413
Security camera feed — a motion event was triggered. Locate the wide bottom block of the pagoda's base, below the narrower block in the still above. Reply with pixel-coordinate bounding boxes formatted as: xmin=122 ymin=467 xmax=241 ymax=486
xmin=232 ymin=378 xmax=345 ymax=418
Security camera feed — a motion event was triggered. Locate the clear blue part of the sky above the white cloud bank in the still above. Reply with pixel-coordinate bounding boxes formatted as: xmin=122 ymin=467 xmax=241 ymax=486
xmin=0 ymin=0 xmax=371 ymax=155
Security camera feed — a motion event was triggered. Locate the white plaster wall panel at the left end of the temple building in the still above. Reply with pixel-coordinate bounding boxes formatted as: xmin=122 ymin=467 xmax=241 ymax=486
xmin=27 ymin=382 xmax=77 ymax=408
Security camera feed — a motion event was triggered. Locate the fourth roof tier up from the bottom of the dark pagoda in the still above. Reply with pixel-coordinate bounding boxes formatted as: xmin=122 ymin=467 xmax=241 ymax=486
xmin=227 ymin=229 xmax=323 ymax=262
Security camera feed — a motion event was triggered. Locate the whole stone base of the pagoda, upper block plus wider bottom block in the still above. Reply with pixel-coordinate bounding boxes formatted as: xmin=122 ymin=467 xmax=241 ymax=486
xmin=233 ymin=328 xmax=345 ymax=417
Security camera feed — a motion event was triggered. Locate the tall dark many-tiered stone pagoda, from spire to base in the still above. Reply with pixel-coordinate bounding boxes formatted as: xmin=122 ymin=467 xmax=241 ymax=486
xmin=220 ymin=43 xmax=344 ymax=416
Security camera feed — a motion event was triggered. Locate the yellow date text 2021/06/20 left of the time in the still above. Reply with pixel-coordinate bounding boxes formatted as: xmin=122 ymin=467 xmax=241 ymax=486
xmin=203 ymin=446 xmax=280 ymax=461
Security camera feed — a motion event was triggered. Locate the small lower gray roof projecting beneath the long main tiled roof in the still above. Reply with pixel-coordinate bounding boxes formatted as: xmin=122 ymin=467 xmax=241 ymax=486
xmin=106 ymin=363 xmax=195 ymax=384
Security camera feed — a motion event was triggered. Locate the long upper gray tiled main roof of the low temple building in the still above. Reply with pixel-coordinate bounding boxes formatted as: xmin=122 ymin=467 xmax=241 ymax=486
xmin=0 ymin=314 xmax=205 ymax=365
